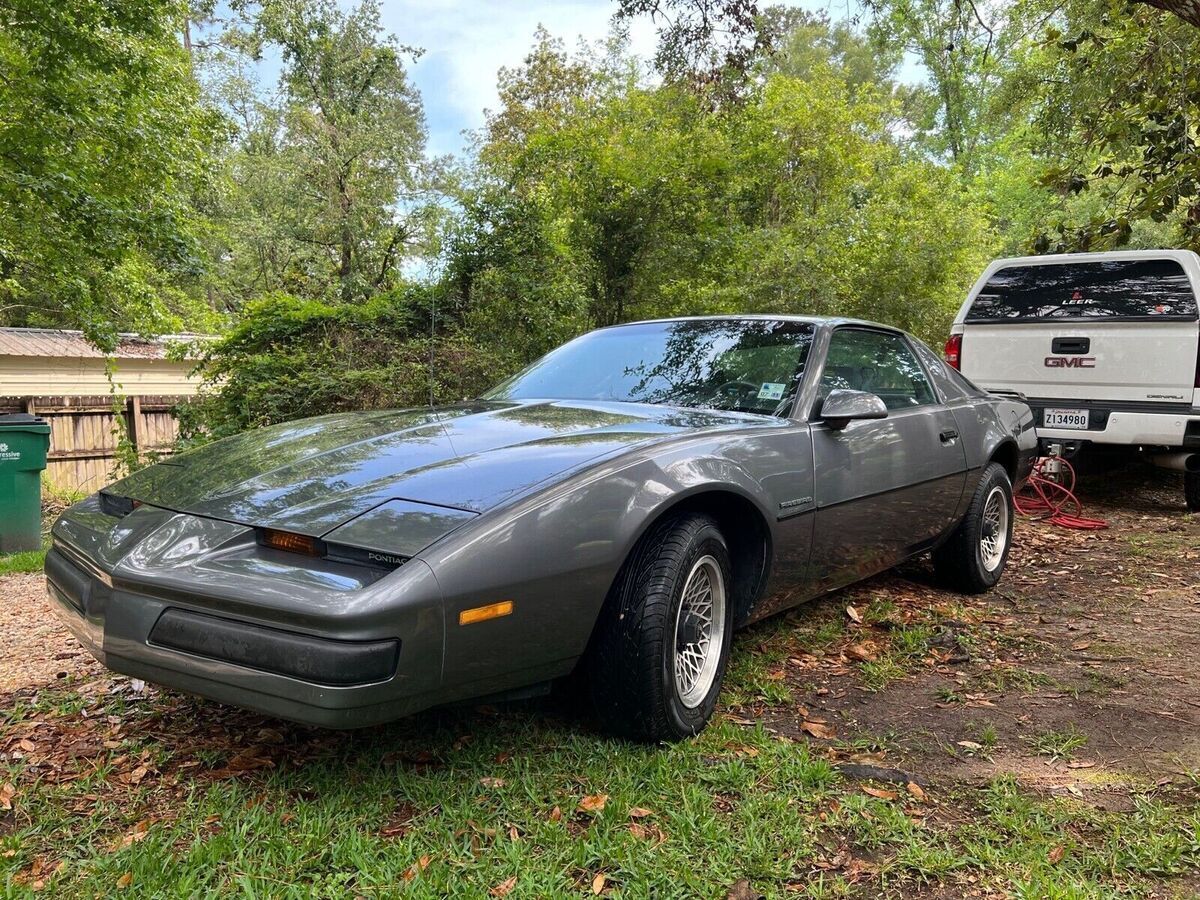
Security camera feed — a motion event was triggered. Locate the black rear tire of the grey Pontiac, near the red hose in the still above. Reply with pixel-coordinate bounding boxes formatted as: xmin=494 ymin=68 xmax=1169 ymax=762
xmin=934 ymin=462 xmax=1014 ymax=594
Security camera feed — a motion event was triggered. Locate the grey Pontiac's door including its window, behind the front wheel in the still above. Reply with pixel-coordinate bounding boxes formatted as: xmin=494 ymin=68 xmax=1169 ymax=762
xmin=811 ymin=326 xmax=966 ymax=590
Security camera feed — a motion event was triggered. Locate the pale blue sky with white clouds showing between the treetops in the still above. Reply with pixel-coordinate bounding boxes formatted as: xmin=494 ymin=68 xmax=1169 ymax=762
xmin=382 ymin=0 xmax=846 ymax=155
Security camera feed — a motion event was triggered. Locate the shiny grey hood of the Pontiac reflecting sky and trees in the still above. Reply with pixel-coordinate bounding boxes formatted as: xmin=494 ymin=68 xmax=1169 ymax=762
xmin=106 ymin=401 xmax=782 ymax=542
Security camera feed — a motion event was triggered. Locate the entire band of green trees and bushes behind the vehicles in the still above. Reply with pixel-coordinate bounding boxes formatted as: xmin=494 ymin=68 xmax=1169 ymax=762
xmin=14 ymin=0 xmax=1200 ymax=441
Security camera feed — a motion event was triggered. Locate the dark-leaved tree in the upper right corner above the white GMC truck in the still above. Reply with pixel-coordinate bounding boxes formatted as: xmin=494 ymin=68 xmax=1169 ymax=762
xmin=1024 ymin=0 xmax=1200 ymax=251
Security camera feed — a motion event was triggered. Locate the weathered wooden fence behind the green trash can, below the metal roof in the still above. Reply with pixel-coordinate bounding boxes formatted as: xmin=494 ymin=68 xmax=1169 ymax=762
xmin=0 ymin=396 xmax=187 ymax=493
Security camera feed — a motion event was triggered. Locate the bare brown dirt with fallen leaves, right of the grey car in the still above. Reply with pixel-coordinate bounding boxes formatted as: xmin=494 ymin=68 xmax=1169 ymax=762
xmin=738 ymin=467 xmax=1200 ymax=809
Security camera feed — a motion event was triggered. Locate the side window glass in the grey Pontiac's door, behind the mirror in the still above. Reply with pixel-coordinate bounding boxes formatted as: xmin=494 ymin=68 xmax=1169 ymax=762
xmin=818 ymin=328 xmax=934 ymax=409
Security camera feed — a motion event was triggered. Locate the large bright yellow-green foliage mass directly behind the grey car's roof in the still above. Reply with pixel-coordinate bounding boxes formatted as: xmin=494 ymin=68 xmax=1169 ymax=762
xmin=448 ymin=25 xmax=988 ymax=354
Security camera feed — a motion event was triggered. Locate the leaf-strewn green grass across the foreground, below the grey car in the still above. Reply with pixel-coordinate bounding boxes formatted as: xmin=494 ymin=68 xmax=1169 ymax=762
xmin=0 ymin=672 xmax=1200 ymax=898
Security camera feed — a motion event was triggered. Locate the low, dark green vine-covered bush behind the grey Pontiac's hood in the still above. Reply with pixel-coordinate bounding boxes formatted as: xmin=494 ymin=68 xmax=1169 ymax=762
xmin=180 ymin=289 xmax=494 ymax=442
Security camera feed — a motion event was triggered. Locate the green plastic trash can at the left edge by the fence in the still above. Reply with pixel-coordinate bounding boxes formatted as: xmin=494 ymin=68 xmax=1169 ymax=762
xmin=0 ymin=413 xmax=50 ymax=553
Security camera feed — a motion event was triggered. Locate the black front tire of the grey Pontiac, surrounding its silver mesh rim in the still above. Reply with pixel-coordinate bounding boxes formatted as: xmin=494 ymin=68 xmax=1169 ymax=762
xmin=586 ymin=514 xmax=733 ymax=742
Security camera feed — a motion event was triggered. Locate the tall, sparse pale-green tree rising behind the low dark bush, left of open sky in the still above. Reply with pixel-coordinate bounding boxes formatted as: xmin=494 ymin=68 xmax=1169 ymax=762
xmin=210 ymin=0 xmax=432 ymax=307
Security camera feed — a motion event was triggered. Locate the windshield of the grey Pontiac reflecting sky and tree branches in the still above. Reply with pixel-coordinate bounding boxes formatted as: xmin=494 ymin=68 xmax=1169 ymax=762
xmin=486 ymin=319 xmax=814 ymax=415
